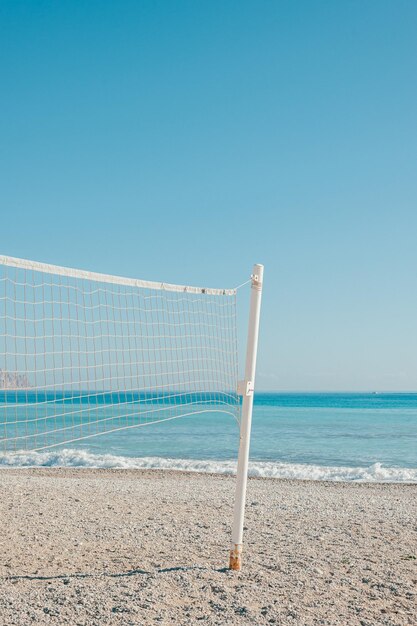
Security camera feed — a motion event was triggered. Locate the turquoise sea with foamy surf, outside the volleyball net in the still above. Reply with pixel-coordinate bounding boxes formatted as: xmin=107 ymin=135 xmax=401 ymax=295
xmin=0 ymin=393 xmax=417 ymax=483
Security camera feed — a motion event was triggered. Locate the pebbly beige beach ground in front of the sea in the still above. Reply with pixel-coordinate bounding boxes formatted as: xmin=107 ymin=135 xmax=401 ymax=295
xmin=0 ymin=468 xmax=417 ymax=626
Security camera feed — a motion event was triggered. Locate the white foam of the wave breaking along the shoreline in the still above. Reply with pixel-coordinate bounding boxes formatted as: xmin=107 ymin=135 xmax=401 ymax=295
xmin=0 ymin=449 xmax=417 ymax=483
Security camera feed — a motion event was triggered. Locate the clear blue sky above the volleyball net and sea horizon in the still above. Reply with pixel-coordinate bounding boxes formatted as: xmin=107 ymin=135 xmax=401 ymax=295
xmin=0 ymin=0 xmax=417 ymax=390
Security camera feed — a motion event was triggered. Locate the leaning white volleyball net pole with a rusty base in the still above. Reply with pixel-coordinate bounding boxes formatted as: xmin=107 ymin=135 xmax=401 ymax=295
xmin=229 ymin=265 xmax=264 ymax=570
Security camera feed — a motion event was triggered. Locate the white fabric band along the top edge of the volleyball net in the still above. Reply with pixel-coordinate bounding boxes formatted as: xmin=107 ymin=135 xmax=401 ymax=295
xmin=0 ymin=255 xmax=236 ymax=296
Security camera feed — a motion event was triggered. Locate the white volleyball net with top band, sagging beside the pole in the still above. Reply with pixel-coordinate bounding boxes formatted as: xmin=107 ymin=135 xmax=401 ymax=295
xmin=0 ymin=257 xmax=239 ymax=450
